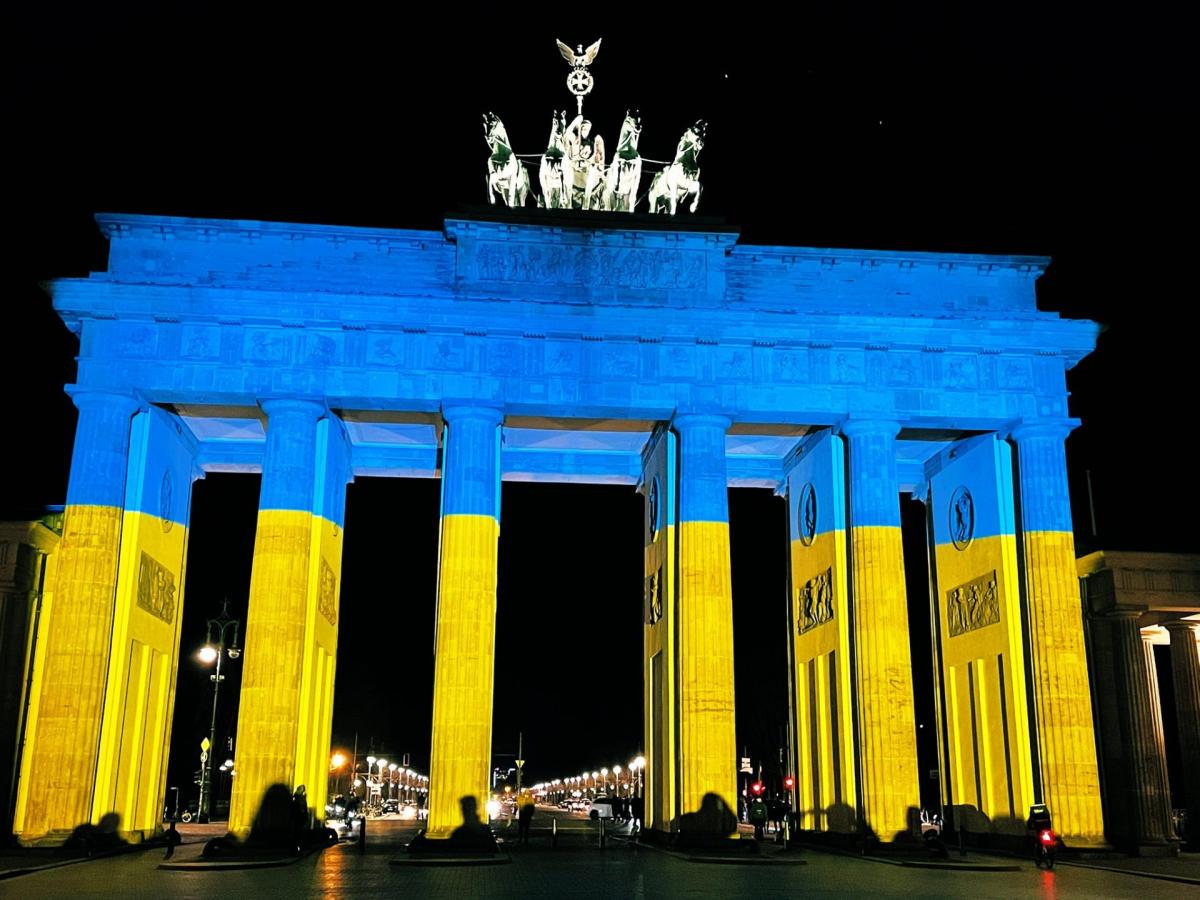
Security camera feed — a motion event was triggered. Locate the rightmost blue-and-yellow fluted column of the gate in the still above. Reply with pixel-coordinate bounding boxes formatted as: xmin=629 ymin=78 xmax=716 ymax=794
xmin=1010 ymin=421 xmax=1104 ymax=846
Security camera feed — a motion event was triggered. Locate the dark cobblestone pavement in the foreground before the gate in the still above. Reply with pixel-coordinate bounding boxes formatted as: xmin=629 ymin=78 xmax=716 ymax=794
xmin=0 ymin=823 xmax=1198 ymax=900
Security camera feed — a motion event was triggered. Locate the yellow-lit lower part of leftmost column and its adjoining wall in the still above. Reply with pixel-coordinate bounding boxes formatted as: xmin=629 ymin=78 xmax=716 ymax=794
xmin=13 ymin=506 xmax=187 ymax=844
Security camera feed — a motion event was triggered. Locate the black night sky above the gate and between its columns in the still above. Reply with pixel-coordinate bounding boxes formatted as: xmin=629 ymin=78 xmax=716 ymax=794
xmin=7 ymin=4 xmax=1200 ymax=811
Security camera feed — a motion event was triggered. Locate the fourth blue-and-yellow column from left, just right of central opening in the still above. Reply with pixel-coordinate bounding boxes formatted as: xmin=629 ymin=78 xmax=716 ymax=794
xmin=673 ymin=415 xmax=738 ymax=814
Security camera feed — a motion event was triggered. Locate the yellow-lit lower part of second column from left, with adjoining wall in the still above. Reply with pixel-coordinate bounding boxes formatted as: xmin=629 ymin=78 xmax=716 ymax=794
xmin=229 ymin=510 xmax=342 ymax=834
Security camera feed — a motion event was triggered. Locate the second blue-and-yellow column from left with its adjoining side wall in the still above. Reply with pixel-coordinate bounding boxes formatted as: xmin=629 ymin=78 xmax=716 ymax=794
xmin=229 ymin=398 xmax=348 ymax=833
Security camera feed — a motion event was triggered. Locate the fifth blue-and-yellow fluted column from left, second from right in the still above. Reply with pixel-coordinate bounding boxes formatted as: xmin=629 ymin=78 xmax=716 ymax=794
xmin=842 ymin=420 xmax=920 ymax=841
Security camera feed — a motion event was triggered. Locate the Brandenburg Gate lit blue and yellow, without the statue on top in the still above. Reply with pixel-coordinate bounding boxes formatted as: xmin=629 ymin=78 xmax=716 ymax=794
xmin=14 ymin=208 xmax=1104 ymax=846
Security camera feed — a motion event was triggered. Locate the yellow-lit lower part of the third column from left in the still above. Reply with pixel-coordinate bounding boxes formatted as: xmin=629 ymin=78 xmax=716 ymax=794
xmin=426 ymin=514 xmax=500 ymax=839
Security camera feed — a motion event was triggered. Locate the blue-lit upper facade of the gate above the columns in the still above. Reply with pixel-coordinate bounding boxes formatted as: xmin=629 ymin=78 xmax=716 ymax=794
xmin=52 ymin=212 xmax=1098 ymax=488
